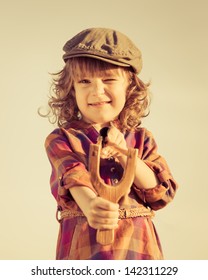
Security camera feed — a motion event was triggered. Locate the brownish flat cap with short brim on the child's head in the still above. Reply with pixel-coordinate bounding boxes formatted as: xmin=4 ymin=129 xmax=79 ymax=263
xmin=63 ymin=28 xmax=142 ymax=74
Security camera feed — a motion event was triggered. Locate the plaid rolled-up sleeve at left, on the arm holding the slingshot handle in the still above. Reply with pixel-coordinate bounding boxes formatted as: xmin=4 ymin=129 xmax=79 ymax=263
xmin=45 ymin=129 xmax=96 ymax=206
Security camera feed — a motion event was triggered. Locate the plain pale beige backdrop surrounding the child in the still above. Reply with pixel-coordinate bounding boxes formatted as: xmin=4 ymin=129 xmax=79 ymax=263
xmin=0 ymin=0 xmax=208 ymax=260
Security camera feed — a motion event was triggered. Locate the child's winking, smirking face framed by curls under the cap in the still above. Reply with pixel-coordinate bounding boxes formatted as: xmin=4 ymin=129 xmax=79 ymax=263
xmin=74 ymin=69 xmax=129 ymax=127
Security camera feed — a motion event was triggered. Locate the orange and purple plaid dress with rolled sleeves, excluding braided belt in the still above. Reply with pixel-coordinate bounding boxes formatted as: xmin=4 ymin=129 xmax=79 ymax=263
xmin=45 ymin=124 xmax=178 ymax=260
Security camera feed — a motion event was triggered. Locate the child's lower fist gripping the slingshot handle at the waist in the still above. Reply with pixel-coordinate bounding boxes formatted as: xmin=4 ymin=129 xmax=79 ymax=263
xmin=85 ymin=196 xmax=119 ymax=229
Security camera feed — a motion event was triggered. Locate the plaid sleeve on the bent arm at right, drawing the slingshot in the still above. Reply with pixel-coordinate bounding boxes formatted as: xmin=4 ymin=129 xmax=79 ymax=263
xmin=134 ymin=129 xmax=178 ymax=210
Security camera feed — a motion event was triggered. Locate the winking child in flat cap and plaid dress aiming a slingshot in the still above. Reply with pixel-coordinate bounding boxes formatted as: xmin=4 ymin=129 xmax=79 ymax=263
xmin=45 ymin=28 xmax=177 ymax=260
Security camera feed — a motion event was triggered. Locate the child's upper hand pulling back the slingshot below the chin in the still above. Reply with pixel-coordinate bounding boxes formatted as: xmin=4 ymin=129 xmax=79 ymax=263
xmin=100 ymin=122 xmax=128 ymax=159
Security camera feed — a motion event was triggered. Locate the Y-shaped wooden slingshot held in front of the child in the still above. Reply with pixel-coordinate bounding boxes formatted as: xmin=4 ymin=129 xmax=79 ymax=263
xmin=89 ymin=137 xmax=138 ymax=245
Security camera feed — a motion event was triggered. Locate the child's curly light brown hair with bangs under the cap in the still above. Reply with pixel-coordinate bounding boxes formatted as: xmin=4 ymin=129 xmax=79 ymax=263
xmin=43 ymin=57 xmax=150 ymax=132
